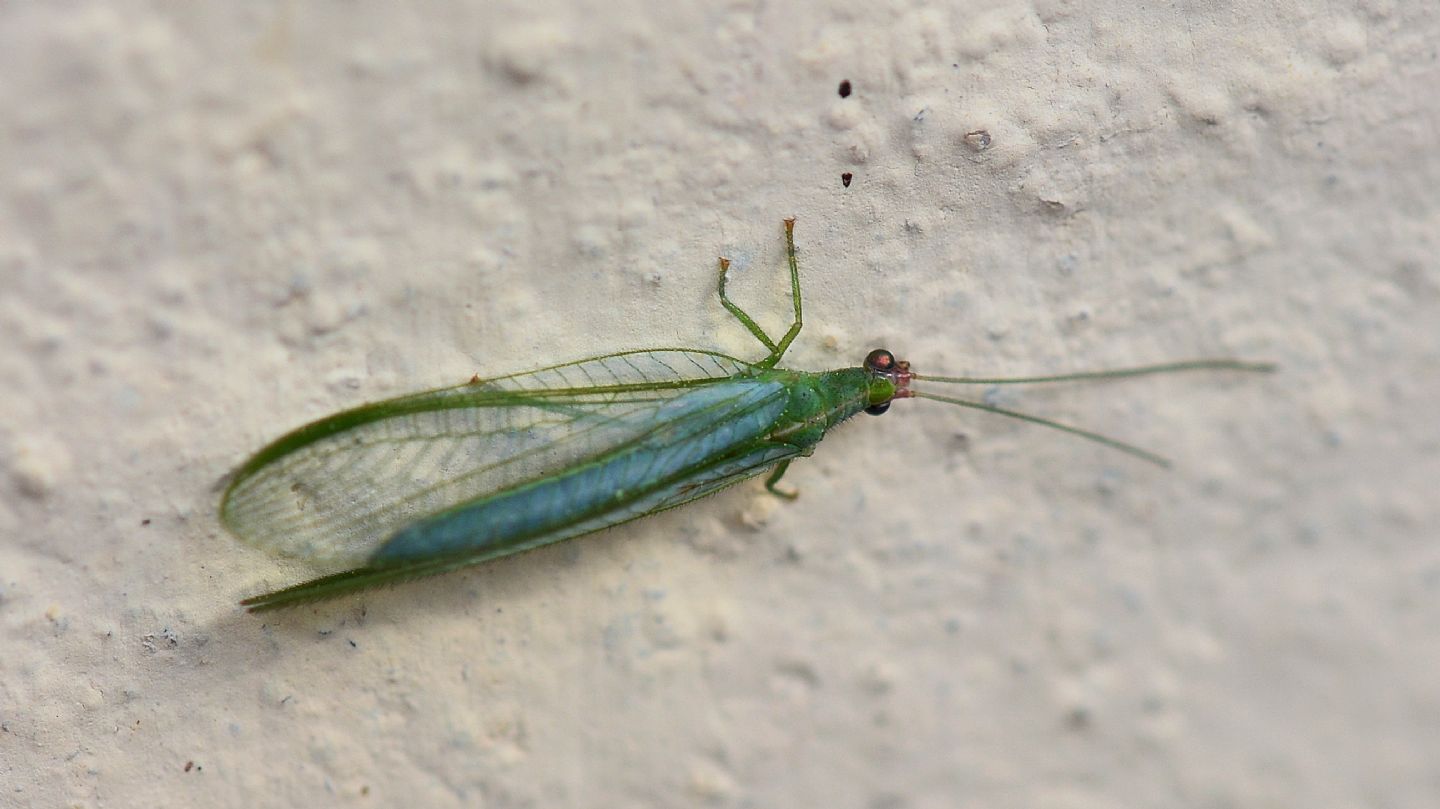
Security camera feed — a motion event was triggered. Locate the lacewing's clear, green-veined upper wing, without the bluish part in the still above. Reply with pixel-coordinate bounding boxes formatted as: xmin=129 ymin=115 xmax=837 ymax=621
xmin=220 ymin=348 xmax=752 ymax=564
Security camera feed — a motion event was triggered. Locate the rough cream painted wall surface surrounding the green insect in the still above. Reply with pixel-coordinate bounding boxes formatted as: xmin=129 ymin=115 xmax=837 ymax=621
xmin=0 ymin=0 xmax=1440 ymax=809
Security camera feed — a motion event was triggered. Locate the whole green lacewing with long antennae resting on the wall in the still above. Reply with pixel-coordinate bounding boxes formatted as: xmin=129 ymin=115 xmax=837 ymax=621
xmin=220 ymin=219 xmax=1273 ymax=612
